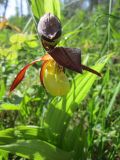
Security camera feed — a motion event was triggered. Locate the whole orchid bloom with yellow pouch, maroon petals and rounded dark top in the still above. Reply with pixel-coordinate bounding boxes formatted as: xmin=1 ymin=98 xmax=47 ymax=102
xmin=10 ymin=13 xmax=101 ymax=96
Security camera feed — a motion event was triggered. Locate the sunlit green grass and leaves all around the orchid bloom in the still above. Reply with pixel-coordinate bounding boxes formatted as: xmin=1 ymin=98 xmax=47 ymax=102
xmin=0 ymin=0 xmax=120 ymax=160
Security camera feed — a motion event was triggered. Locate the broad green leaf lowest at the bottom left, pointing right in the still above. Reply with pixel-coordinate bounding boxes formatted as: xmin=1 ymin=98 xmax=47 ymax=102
xmin=0 ymin=139 xmax=71 ymax=160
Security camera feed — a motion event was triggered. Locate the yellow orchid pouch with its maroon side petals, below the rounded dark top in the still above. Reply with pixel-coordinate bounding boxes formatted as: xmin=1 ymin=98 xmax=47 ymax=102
xmin=10 ymin=47 xmax=101 ymax=96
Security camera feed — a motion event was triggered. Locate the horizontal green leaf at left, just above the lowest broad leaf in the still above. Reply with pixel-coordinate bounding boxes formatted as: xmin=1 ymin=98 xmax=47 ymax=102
xmin=0 ymin=126 xmax=51 ymax=145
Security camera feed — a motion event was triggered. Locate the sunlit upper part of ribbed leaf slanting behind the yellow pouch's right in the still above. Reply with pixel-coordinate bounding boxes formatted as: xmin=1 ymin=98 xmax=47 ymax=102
xmin=66 ymin=55 xmax=111 ymax=114
